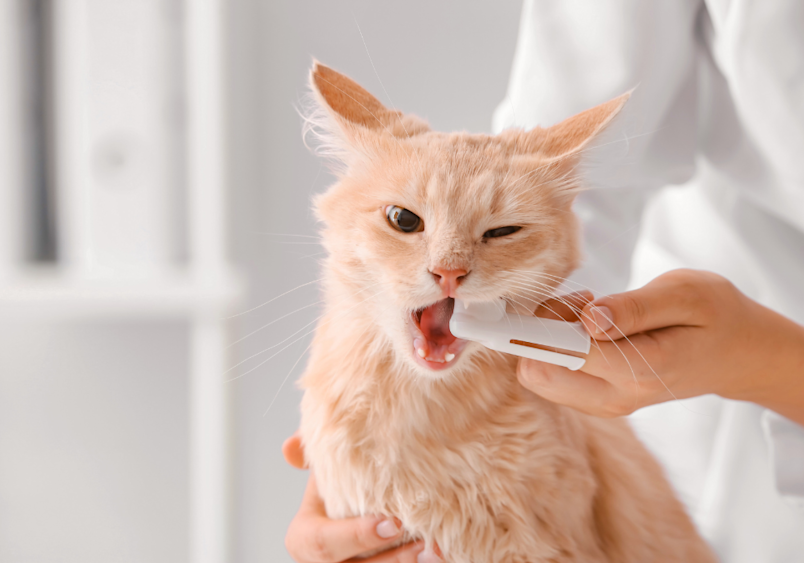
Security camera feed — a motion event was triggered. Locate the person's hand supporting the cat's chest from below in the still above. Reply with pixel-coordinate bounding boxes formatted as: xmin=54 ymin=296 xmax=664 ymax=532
xmin=282 ymin=435 xmax=441 ymax=563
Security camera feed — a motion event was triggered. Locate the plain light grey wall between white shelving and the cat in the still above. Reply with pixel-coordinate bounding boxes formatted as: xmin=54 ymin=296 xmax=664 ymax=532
xmin=230 ymin=0 xmax=521 ymax=563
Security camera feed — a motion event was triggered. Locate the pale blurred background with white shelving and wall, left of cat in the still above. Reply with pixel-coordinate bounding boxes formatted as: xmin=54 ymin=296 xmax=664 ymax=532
xmin=0 ymin=0 xmax=521 ymax=563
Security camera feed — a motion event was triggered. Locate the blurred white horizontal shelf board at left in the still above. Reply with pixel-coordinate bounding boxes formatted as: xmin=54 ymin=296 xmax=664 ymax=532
xmin=0 ymin=268 xmax=244 ymax=322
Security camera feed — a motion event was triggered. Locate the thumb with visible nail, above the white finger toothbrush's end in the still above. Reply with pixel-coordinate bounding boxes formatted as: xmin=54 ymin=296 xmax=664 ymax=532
xmin=582 ymin=276 xmax=694 ymax=340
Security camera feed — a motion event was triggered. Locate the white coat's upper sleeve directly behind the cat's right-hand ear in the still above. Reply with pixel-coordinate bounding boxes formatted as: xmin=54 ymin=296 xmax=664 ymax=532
xmin=494 ymin=0 xmax=701 ymax=294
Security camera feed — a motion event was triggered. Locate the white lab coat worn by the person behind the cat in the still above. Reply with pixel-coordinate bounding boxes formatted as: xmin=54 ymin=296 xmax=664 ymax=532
xmin=495 ymin=0 xmax=804 ymax=563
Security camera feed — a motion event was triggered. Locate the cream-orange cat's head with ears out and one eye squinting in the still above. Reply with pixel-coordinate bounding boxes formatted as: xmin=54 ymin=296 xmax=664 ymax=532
xmin=308 ymin=63 xmax=628 ymax=377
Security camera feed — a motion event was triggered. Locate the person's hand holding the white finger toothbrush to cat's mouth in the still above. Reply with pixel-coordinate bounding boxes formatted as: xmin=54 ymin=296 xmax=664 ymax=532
xmin=518 ymin=270 xmax=804 ymax=423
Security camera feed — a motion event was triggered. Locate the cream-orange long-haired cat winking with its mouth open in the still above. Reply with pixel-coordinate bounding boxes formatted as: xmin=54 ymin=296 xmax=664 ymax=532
xmin=299 ymin=62 xmax=715 ymax=563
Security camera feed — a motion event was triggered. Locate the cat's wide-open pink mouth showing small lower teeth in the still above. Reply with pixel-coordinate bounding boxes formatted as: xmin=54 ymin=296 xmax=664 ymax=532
xmin=409 ymin=297 xmax=466 ymax=370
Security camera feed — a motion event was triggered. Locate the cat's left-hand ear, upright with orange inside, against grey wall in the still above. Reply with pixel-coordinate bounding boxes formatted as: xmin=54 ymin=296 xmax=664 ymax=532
xmin=310 ymin=61 xmax=430 ymax=161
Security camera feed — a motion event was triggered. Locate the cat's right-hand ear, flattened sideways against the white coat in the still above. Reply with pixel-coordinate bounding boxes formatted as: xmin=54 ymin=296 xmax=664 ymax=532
xmin=538 ymin=90 xmax=633 ymax=158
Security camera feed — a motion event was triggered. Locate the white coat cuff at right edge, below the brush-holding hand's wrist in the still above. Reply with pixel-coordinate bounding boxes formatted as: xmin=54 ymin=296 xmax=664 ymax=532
xmin=762 ymin=410 xmax=804 ymax=515
